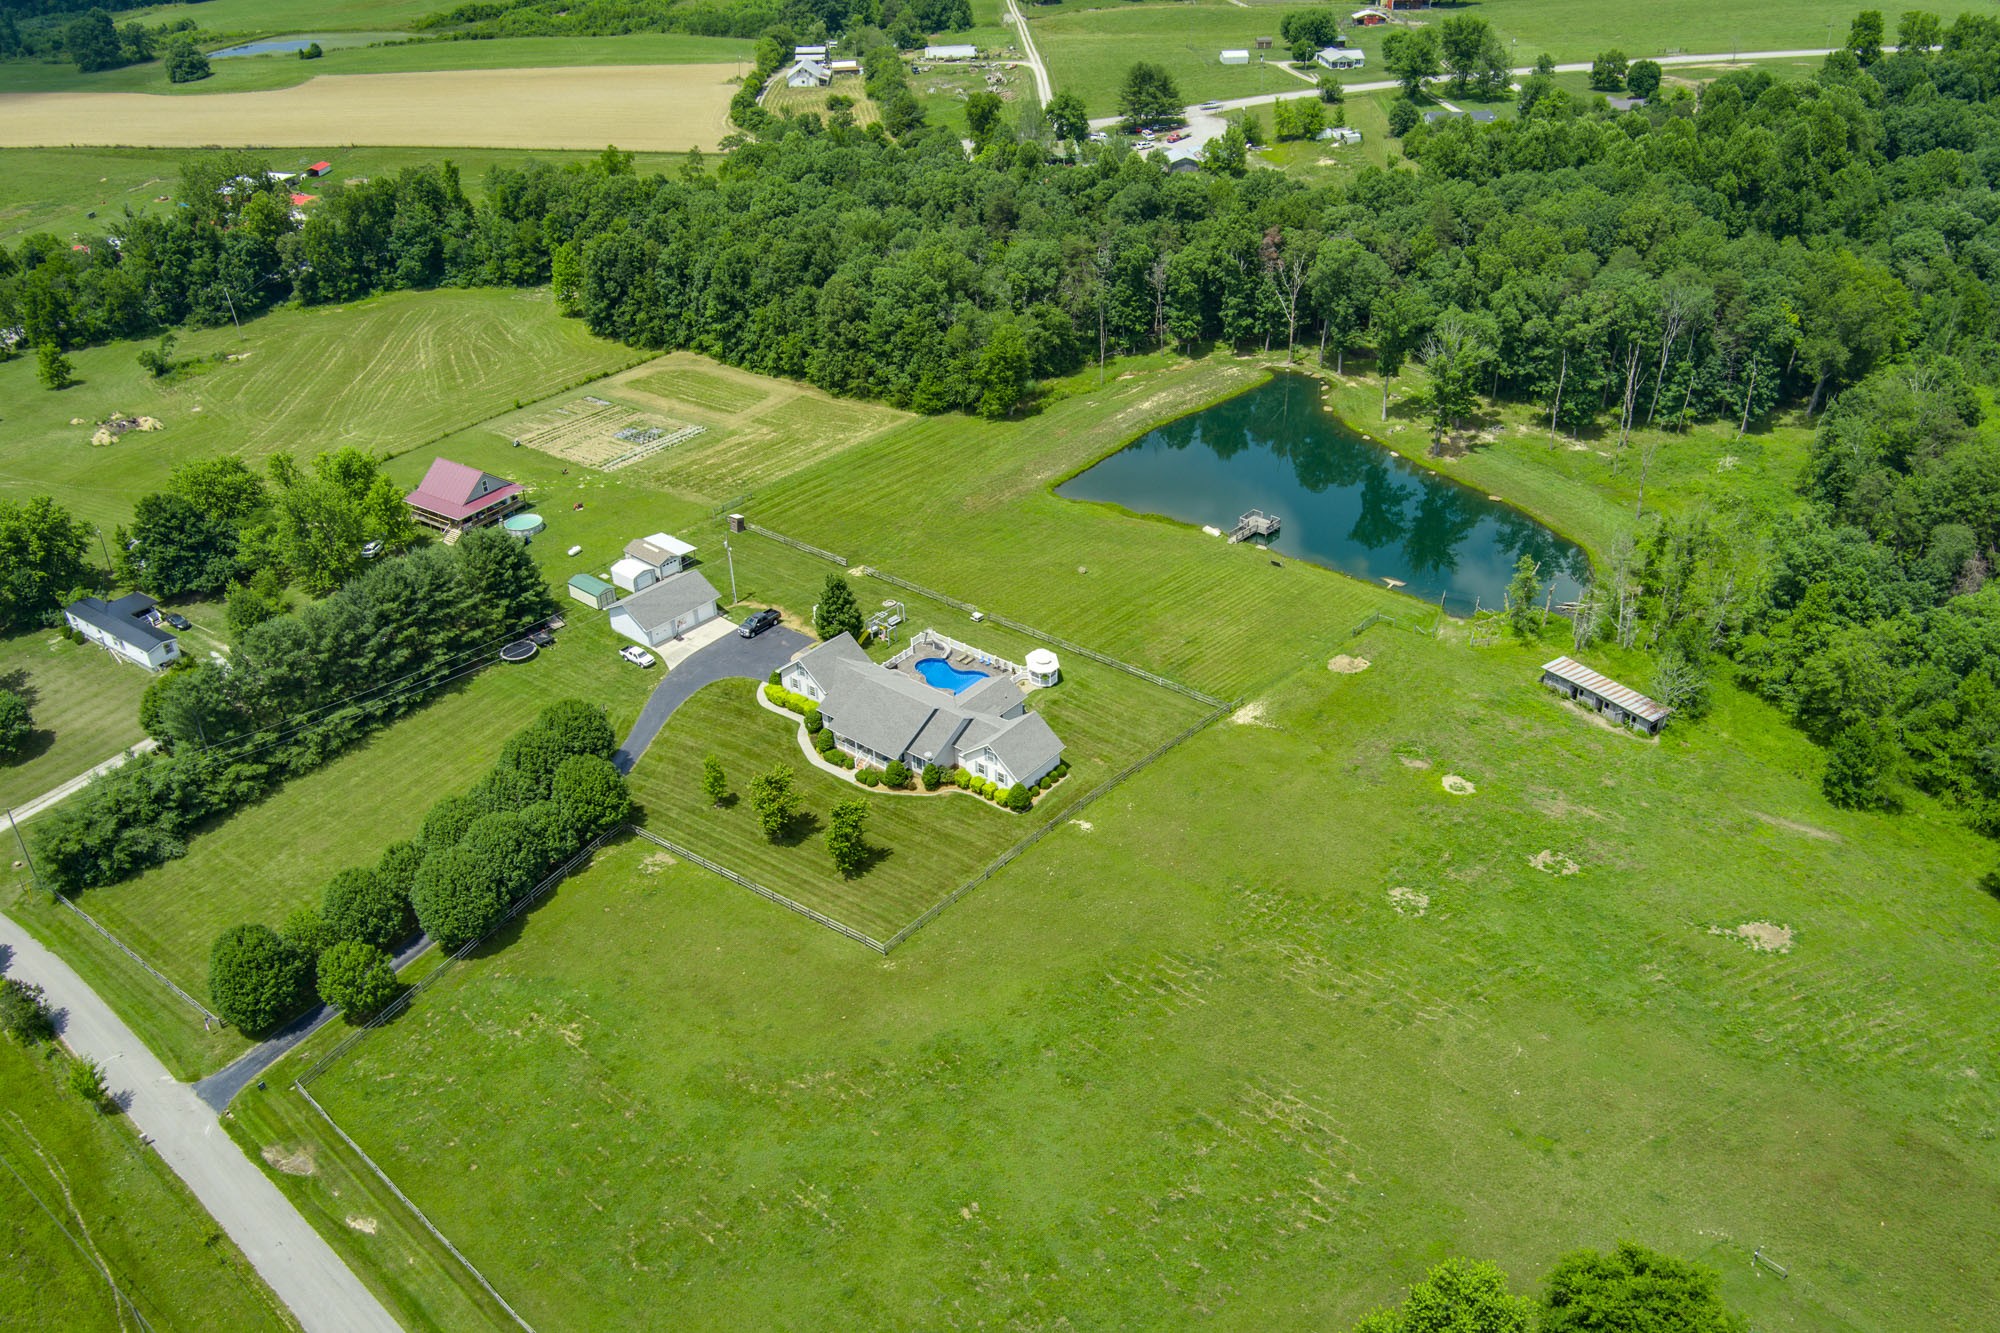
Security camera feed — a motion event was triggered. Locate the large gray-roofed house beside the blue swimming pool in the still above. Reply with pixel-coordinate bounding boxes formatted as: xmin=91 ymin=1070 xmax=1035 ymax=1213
xmin=778 ymin=634 xmax=1062 ymax=787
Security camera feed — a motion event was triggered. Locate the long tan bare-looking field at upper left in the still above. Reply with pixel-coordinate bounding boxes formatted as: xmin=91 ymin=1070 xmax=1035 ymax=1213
xmin=0 ymin=64 xmax=732 ymax=152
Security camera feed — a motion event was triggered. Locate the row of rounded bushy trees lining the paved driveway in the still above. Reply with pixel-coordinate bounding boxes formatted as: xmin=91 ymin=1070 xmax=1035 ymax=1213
xmin=208 ymin=699 xmax=632 ymax=1035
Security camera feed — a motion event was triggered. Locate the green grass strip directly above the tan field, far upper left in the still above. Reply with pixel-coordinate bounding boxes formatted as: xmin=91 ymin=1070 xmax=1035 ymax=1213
xmin=0 ymin=33 xmax=756 ymax=96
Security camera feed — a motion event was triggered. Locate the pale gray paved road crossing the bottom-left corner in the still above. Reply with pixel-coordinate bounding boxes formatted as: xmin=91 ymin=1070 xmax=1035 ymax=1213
xmin=0 ymin=915 xmax=398 ymax=1333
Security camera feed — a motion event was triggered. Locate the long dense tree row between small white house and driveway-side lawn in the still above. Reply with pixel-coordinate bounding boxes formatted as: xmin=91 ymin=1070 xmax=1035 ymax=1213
xmin=34 ymin=528 xmax=556 ymax=893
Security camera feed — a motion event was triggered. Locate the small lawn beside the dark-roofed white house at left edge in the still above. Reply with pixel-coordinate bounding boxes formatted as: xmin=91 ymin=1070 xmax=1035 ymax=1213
xmin=0 ymin=630 xmax=152 ymax=804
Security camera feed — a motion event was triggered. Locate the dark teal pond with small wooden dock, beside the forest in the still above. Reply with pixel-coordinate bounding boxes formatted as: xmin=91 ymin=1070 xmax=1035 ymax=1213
xmin=1056 ymin=374 xmax=1590 ymax=614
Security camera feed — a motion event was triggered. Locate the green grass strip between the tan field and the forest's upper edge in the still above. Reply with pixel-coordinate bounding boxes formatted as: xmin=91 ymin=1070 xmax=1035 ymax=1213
xmin=0 ymin=148 xmax=704 ymax=244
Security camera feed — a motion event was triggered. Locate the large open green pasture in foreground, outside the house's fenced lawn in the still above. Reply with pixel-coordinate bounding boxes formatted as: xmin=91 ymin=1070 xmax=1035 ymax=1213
xmin=258 ymin=622 xmax=2000 ymax=1329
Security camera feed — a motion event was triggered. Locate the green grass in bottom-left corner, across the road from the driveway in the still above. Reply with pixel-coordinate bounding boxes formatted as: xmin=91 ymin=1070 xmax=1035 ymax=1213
xmin=0 ymin=1041 xmax=298 ymax=1333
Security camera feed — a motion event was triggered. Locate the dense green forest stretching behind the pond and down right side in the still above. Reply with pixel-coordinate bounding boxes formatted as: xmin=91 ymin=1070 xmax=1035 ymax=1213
xmin=11 ymin=16 xmax=2000 ymax=833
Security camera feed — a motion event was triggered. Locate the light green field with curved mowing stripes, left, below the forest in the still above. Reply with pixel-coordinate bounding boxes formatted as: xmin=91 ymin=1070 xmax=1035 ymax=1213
xmin=0 ymin=290 xmax=636 ymax=532
